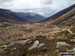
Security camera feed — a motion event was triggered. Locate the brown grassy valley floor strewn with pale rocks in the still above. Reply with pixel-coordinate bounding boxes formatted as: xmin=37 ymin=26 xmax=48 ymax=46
xmin=0 ymin=22 xmax=75 ymax=56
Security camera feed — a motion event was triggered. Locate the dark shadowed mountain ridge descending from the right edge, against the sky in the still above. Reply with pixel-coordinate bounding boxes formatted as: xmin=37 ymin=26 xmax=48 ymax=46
xmin=43 ymin=4 xmax=75 ymax=21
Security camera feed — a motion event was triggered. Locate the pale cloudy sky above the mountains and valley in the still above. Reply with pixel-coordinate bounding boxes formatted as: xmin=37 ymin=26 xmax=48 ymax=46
xmin=0 ymin=0 xmax=75 ymax=17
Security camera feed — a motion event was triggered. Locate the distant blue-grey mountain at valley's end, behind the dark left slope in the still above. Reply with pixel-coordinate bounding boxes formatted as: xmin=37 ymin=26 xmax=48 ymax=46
xmin=14 ymin=12 xmax=44 ymax=22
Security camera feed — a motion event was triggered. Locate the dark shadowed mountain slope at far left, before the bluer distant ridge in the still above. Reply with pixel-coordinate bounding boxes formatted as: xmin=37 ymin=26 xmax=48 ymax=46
xmin=0 ymin=9 xmax=26 ymax=21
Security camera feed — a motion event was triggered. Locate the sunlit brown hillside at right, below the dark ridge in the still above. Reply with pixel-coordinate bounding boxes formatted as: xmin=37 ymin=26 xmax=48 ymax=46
xmin=52 ymin=8 xmax=75 ymax=25
